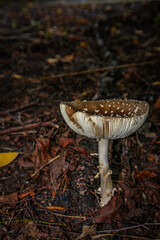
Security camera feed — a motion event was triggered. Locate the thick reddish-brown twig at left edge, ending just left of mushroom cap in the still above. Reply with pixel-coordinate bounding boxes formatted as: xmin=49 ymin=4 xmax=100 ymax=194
xmin=0 ymin=122 xmax=59 ymax=135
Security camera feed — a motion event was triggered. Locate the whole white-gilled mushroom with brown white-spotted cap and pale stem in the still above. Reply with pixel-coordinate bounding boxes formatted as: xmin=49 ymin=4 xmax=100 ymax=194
xmin=60 ymin=99 xmax=149 ymax=206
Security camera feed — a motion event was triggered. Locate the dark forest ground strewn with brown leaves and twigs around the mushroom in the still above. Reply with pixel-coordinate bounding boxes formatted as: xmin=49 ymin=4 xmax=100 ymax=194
xmin=0 ymin=1 xmax=160 ymax=240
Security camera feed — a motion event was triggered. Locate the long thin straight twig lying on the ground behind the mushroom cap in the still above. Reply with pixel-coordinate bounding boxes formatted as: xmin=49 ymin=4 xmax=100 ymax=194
xmin=40 ymin=60 xmax=158 ymax=80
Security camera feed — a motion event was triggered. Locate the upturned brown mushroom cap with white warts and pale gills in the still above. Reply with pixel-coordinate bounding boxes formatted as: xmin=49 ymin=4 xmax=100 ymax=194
xmin=60 ymin=99 xmax=149 ymax=139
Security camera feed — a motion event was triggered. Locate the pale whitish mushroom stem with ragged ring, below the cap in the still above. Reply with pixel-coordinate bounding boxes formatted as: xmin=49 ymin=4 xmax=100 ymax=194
xmin=98 ymin=139 xmax=113 ymax=207
